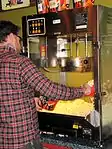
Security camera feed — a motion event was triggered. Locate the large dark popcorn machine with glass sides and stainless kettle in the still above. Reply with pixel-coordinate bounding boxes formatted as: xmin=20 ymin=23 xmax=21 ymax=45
xmin=22 ymin=6 xmax=112 ymax=145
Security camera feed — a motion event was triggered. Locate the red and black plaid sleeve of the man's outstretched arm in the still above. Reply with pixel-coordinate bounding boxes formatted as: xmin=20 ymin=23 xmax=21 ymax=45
xmin=20 ymin=58 xmax=83 ymax=99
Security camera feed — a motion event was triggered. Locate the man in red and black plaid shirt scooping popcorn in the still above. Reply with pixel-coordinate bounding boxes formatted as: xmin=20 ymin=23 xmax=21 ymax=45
xmin=0 ymin=21 xmax=93 ymax=149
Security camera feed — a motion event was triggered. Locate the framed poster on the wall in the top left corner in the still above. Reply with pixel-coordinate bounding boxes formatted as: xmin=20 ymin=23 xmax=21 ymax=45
xmin=1 ymin=0 xmax=30 ymax=10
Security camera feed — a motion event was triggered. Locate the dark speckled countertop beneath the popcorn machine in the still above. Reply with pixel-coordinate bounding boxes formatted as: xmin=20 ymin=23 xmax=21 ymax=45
xmin=41 ymin=134 xmax=100 ymax=149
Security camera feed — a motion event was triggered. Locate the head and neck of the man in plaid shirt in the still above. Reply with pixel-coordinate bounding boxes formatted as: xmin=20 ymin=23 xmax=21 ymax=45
xmin=0 ymin=20 xmax=21 ymax=52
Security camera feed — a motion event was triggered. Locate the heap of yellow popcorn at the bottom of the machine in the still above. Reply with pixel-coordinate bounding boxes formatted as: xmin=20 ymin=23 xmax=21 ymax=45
xmin=42 ymin=97 xmax=94 ymax=117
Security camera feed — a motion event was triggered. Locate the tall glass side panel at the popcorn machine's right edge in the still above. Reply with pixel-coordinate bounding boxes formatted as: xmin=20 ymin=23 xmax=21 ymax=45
xmin=100 ymin=5 xmax=112 ymax=137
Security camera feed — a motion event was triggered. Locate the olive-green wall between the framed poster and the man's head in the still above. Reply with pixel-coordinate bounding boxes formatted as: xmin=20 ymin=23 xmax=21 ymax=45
xmin=0 ymin=6 xmax=36 ymax=35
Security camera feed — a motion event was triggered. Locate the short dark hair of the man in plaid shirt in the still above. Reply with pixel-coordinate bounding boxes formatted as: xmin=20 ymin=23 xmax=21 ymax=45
xmin=0 ymin=20 xmax=20 ymax=42
